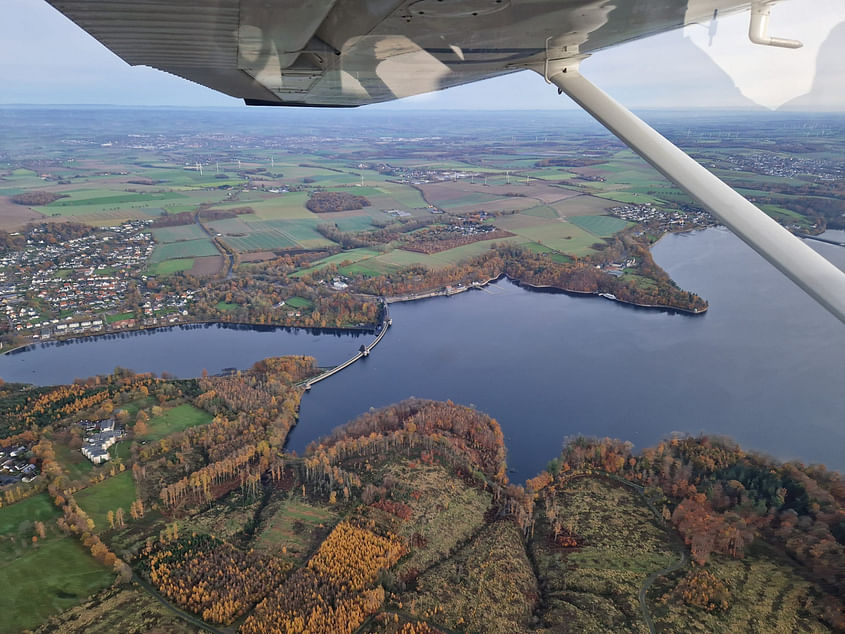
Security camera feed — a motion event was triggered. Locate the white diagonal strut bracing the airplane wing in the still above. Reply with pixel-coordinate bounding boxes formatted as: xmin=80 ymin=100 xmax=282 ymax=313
xmin=536 ymin=65 xmax=845 ymax=323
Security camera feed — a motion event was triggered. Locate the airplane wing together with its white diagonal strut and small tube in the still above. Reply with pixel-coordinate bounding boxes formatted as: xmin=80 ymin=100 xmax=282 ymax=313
xmin=42 ymin=0 xmax=845 ymax=322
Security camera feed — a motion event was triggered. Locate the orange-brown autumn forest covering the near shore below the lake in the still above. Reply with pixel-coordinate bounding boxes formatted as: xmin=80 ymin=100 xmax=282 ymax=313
xmin=0 ymin=357 xmax=845 ymax=634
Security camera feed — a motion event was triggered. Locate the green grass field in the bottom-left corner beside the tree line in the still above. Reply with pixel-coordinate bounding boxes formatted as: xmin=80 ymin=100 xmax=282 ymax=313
xmin=0 ymin=537 xmax=114 ymax=632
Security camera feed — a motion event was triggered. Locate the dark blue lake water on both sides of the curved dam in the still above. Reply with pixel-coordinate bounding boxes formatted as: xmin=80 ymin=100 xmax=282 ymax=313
xmin=0 ymin=229 xmax=845 ymax=481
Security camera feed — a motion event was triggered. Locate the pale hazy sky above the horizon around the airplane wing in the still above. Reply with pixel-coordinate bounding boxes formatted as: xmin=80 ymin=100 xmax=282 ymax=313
xmin=0 ymin=0 xmax=845 ymax=111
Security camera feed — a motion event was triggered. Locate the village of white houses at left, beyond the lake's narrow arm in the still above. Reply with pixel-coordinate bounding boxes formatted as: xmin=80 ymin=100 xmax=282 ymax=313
xmin=0 ymin=220 xmax=201 ymax=341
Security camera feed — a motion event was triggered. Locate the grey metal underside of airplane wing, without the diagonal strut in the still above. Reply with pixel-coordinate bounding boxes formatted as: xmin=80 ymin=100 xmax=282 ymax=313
xmin=48 ymin=0 xmax=748 ymax=106
